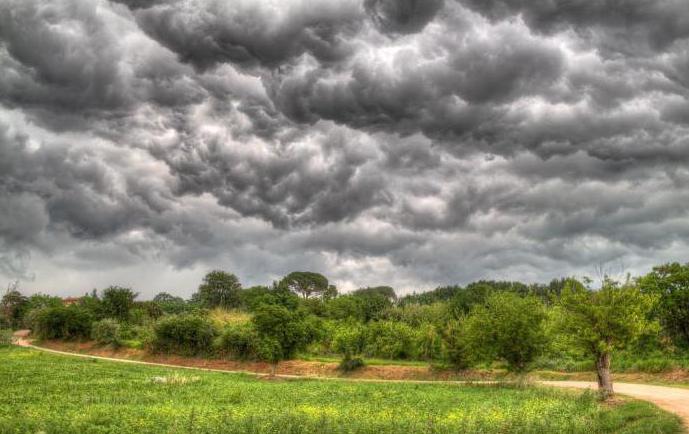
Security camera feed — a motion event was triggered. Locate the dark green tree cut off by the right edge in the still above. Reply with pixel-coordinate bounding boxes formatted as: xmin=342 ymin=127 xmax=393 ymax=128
xmin=637 ymin=262 xmax=689 ymax=348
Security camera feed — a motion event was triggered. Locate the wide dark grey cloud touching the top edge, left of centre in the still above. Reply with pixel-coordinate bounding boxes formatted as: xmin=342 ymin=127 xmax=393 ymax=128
xmin=136 ymin=0 xmax=361 ymax=69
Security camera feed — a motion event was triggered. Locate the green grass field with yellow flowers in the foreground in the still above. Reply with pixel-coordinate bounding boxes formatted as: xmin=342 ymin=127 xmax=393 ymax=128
xmin=0 ymin=348 xmax=682 ymax=434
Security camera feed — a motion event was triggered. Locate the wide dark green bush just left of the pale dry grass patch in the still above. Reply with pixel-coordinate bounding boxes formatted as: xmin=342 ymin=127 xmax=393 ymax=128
xmin=152 ymin=315 xmax=217 ymax=355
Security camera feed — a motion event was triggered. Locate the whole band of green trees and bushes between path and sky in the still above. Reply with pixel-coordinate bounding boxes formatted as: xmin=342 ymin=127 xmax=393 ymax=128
xmin=0 ymin=263 xmax=689 ymax=396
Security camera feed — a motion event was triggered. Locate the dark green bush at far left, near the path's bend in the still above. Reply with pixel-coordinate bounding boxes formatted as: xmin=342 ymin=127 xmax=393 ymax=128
xmin=33 ymin=306 xmax=93 ymax=339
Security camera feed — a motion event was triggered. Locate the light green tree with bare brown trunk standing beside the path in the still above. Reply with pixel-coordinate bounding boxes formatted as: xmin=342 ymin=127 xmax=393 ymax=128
xmin=555 ymin=278 xmax=654 ymax=398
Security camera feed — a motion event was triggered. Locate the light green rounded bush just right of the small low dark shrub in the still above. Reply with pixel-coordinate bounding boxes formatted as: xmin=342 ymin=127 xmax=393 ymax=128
xmin=364 ymin=321 xmax=415 ymax=359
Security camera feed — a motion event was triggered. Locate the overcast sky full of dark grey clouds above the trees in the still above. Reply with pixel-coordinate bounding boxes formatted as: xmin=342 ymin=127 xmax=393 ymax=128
xmin=0 ymin=0 xmax=689 ymax=296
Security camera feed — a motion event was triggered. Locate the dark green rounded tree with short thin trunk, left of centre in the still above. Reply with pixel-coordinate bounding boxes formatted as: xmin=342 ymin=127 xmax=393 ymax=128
xmin=252 ymin=304 xmax=313 ymax=375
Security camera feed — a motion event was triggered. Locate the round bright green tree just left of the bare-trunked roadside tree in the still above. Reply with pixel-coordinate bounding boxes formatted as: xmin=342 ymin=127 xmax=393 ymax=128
xmin=463 ymin=292 xmax=546 ymax=372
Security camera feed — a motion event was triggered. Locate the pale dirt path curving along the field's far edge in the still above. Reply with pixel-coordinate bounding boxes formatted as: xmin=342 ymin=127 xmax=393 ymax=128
xmin=9 ymin=333 xmax=689 ymax=427
